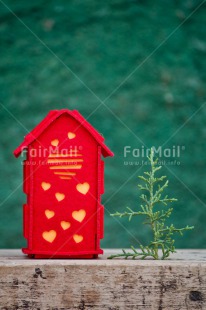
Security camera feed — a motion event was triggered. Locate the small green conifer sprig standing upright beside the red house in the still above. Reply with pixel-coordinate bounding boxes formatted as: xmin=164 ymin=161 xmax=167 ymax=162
xmin=109 ymin=149 xmax=194 ymax=259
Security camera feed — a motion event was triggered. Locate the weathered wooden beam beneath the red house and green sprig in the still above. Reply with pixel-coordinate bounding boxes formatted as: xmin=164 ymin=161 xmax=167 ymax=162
xmin=0 ymin=250 xmax=206 ymax=310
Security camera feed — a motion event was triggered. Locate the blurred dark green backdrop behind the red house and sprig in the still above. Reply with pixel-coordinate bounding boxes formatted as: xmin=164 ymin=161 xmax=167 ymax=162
xmin=0 ymin=0 xmax=206 ymax=248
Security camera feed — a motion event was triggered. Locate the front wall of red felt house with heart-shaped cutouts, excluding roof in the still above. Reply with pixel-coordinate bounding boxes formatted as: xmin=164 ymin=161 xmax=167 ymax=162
xmin=25 ymin=114 xmax=99 ymax=255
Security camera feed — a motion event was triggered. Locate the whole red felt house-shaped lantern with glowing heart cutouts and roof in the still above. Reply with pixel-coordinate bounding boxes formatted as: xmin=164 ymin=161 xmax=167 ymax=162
xmin=14 ymin=110 xmax=113 ymax=258
